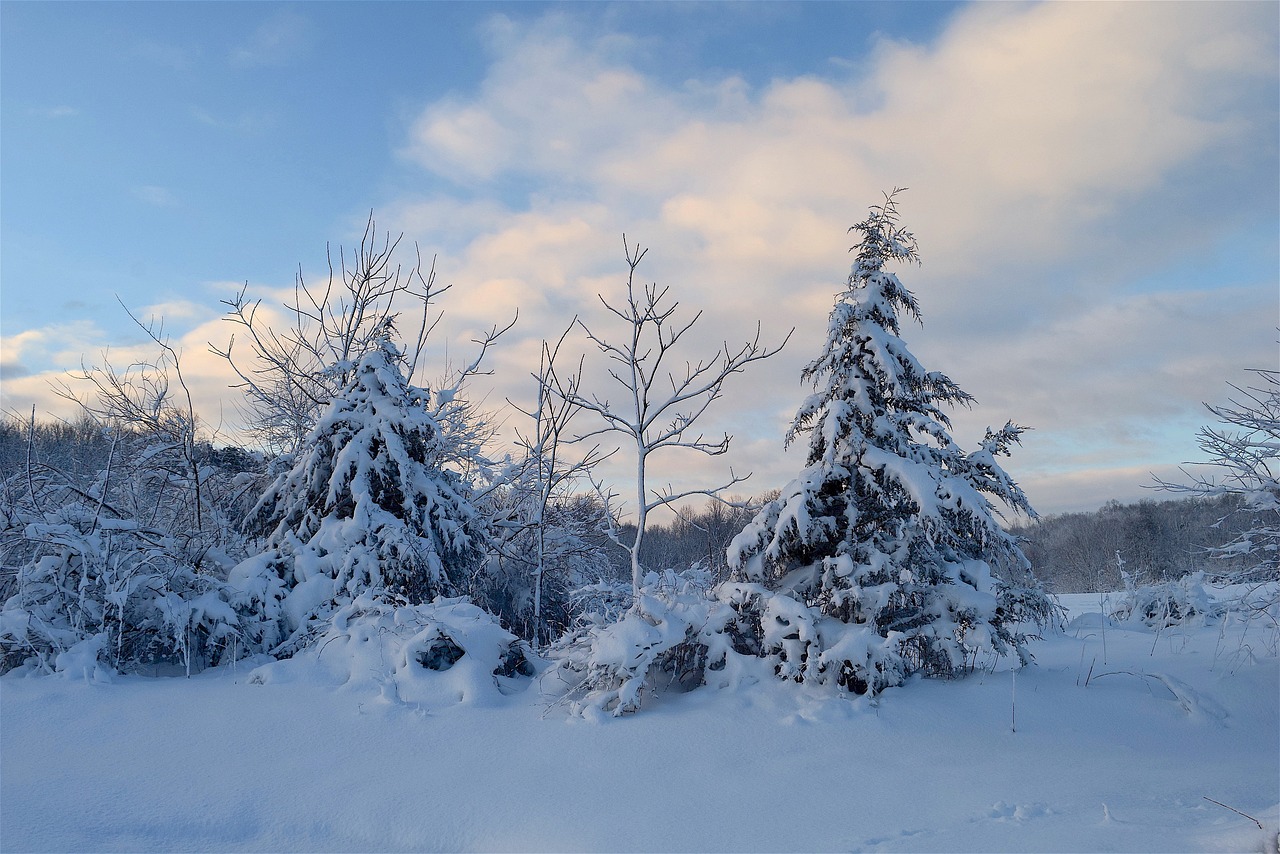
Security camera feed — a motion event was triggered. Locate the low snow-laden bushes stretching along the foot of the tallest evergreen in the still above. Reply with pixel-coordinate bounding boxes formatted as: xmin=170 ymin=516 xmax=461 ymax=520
xmin=549 ymin=561 xmax=1059 ymax=716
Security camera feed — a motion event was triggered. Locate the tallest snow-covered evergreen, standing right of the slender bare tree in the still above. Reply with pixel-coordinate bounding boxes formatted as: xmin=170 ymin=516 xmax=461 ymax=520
xmin=721 ymin=193 xmax=1055 ymax=694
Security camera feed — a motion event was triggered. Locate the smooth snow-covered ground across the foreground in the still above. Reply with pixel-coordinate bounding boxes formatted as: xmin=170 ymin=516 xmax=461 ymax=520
xmin=0 ymin=595 xmax=1280 ymax=851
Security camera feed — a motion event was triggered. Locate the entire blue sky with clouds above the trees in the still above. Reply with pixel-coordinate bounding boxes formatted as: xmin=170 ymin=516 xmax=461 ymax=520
xmin=0 ymin=3 xmax=1280 ymax=512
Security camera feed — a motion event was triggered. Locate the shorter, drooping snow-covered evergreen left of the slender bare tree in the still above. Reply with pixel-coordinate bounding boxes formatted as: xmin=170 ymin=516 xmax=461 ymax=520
xmin=229 ymin=335 xmax=488 ymax=654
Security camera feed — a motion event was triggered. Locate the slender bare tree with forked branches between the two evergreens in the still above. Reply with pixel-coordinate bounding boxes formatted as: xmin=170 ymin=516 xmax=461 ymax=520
xmin=554 ymin=236 xmax=794 ymax=593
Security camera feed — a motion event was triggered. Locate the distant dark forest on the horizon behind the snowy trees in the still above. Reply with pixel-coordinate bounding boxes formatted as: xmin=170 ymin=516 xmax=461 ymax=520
xmin=0 ymin=416 xmax=1253 ymax=600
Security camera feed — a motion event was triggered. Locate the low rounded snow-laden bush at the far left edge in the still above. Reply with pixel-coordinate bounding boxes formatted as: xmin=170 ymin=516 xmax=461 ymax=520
xmin=0 ymin=504 xmax=243 ymax=676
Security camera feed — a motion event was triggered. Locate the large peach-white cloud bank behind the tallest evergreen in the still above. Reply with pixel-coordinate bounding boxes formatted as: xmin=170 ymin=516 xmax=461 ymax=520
xmin=384 ymin=4 xmax=1276 ymax=514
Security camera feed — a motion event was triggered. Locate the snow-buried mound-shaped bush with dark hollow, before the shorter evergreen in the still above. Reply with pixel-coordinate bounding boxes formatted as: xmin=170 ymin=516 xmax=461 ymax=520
xmin=250 ymin=592 xmax=535 ymax=711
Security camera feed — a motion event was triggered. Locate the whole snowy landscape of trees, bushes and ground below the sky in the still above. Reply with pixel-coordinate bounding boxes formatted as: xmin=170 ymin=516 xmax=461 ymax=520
xmin=0 ymin=180 xmax=1280 ymax=853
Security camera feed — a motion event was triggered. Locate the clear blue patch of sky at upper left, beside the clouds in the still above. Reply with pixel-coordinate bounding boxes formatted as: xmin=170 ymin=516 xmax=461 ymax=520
xmin=3 ymin=3 xmax=951 ymax=317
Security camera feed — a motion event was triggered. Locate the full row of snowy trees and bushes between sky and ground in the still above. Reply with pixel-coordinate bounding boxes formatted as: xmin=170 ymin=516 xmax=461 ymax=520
xmin=0 ymin=192 xmax=1275 ymax=714
